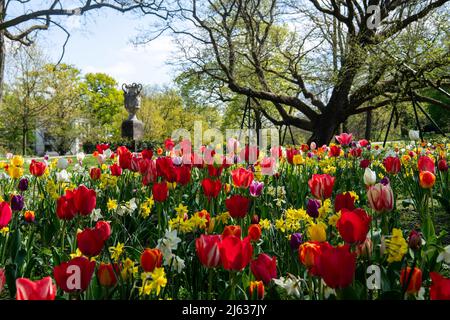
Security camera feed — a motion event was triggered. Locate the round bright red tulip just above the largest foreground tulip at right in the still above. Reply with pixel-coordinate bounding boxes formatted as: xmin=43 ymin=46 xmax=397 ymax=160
xmin=336 ymin=208 xmax=372 ymax=244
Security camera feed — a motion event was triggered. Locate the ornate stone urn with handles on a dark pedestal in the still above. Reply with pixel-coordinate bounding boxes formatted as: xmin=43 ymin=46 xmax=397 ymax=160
xmin=122 ymin=83 xmax=144 ymax=141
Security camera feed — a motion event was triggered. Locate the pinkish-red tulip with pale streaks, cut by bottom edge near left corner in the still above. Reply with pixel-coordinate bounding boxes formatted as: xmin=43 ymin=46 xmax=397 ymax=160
xmin=16 ymin=277 xmax=56 ymax=300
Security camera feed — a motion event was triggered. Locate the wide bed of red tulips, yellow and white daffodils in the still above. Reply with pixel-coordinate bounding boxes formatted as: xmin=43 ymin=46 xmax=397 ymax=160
xmin=0 ymin=134 xmax=450 ymax=300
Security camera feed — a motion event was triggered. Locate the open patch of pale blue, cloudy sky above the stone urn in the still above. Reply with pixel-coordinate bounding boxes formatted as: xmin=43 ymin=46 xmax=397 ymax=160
xmin=39 ymin=9 xmax=176 ymax=85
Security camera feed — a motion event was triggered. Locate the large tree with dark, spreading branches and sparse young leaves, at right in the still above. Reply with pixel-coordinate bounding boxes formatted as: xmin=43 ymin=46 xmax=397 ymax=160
xmin=145 ymin=0 xmax=450 ymax=144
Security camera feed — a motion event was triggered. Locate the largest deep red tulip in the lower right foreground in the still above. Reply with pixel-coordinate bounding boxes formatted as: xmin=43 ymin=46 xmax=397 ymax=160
xmin=315 ymin=245 xmax=356 ymax=289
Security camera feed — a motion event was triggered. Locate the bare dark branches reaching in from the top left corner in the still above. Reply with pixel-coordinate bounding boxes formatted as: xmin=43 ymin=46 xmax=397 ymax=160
xmin=0 ymin=0 xmax=168 ymax=99
